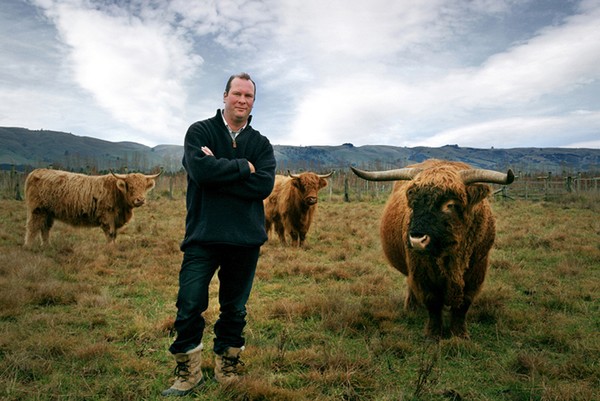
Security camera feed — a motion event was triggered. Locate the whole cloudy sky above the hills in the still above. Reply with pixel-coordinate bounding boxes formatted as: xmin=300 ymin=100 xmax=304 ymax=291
xmin=0 ymin=0 xmax=600 ymax=148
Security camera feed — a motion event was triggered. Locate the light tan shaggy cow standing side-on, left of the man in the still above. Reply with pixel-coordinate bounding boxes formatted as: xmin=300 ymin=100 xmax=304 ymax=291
xmin=25 ymin=169 xmax=160 ymax=247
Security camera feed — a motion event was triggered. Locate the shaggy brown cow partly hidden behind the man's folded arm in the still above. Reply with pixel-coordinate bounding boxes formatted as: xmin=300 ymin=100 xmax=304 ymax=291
xmin=264 ymin=171 xmax=333 ymax=247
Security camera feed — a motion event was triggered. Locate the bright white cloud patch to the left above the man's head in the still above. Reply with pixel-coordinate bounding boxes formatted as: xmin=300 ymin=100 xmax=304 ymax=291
xmin=31 ymin=1 xmax=202 ymax=144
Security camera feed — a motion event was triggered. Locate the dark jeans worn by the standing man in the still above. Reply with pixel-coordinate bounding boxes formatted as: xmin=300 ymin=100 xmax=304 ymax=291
xmin=169 ymin=245 xmax=260 ymax=354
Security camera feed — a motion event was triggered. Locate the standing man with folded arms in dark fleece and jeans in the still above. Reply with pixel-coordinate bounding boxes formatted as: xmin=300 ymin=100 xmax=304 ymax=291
xmin=163 ymin=73 xmax=275 ymax=396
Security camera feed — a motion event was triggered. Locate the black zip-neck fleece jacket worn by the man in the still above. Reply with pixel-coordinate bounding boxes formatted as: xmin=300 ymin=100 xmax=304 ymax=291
xmin=181 ymin=110 xmax=276 ymax=251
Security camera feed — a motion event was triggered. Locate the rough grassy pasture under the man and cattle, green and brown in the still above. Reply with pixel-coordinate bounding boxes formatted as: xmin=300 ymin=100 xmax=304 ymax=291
xmin=0 ymin=190 xmax=600 ymax=401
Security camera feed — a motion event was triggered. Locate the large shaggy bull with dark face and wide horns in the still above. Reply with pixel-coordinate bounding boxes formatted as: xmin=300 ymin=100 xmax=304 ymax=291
xmin=352 ymin=160 xmax=514 ymax=338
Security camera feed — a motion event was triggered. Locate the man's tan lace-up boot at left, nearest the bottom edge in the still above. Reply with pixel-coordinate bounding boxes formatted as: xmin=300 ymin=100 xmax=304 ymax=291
xmin=162 ymin=343 xmax=202 ymax=396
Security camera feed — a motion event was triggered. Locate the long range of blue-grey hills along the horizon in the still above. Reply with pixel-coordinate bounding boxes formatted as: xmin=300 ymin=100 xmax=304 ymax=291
xmin=0 ymin=127 xmax=600 ymax=174
